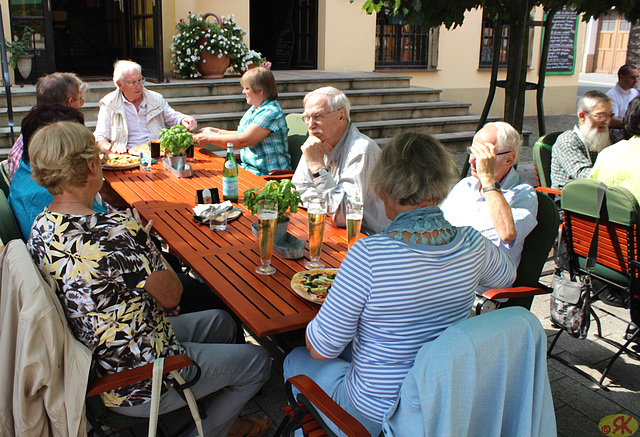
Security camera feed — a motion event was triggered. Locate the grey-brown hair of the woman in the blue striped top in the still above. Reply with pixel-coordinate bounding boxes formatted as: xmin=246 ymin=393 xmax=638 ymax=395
xmin=369 ymin=132 xmax=458 ymax=205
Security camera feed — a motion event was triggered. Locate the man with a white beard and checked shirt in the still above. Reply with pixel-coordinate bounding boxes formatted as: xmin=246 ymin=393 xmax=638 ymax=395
xmin=551 ymin=91 xmax=613 ymax=188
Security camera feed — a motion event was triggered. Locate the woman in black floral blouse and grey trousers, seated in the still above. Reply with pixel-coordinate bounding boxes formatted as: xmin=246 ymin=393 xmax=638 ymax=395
xmin=27 ymin=122 xmax=270 ymax=436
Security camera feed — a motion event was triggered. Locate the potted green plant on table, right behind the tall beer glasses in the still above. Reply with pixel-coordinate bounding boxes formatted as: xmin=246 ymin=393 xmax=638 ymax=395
xmin=243 ymin=179 xmax=304 ymax=259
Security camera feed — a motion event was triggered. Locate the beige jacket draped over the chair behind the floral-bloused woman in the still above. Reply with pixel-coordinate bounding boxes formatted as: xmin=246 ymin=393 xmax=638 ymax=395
xmin=0 ymin=240 xmax=91 ymax=436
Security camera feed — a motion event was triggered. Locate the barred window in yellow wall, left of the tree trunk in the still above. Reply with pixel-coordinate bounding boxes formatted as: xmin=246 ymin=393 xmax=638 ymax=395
xmin=376 ymin=11 xmax=440 ymax=69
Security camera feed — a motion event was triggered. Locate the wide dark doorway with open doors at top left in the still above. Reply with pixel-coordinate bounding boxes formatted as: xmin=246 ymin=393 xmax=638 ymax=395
xmin=10 ymin=0 xmax=164 ymax=82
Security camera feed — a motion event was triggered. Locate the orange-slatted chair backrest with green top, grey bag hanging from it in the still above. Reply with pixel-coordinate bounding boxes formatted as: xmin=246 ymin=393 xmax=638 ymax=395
xmin=561 ymin=179 xmax=640 ymax=286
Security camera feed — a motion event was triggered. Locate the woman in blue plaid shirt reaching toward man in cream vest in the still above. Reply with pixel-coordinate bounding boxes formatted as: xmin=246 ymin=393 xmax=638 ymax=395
xmin=194 ymin=67 xmax=291 ymax=176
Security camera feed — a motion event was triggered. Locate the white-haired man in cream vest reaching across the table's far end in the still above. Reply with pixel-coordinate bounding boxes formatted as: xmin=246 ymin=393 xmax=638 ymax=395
xmin=93 ymin=61 xmax=197 ymax=153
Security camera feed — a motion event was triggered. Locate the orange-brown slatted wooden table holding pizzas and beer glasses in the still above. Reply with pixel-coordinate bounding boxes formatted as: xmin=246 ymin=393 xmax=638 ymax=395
xmin=103 ymin=147 xmax=347 ymax=337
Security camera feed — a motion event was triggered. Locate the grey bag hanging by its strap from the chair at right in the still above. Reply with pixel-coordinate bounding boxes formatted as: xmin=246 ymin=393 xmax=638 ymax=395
xmin=549 ymin=183 xmax=607 ymax=339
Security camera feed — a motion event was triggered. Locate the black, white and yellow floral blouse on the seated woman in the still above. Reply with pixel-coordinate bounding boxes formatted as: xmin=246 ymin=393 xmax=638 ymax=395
xmin=27 ymin=208 xmax=183 ymax=407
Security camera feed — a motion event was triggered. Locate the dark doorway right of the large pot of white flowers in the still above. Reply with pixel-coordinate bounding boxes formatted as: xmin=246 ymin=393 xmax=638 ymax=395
xmin=249 ymin=0 xmax=318 ymax=70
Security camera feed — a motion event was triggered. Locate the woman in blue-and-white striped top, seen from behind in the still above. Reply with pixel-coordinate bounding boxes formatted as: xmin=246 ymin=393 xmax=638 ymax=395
xmin=284 ymin=132 xmax=515 ymax=436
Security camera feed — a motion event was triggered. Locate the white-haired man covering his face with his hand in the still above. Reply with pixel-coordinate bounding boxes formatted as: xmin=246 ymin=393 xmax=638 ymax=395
xmin=441 ymin=122 xmax=538 ymax=267
